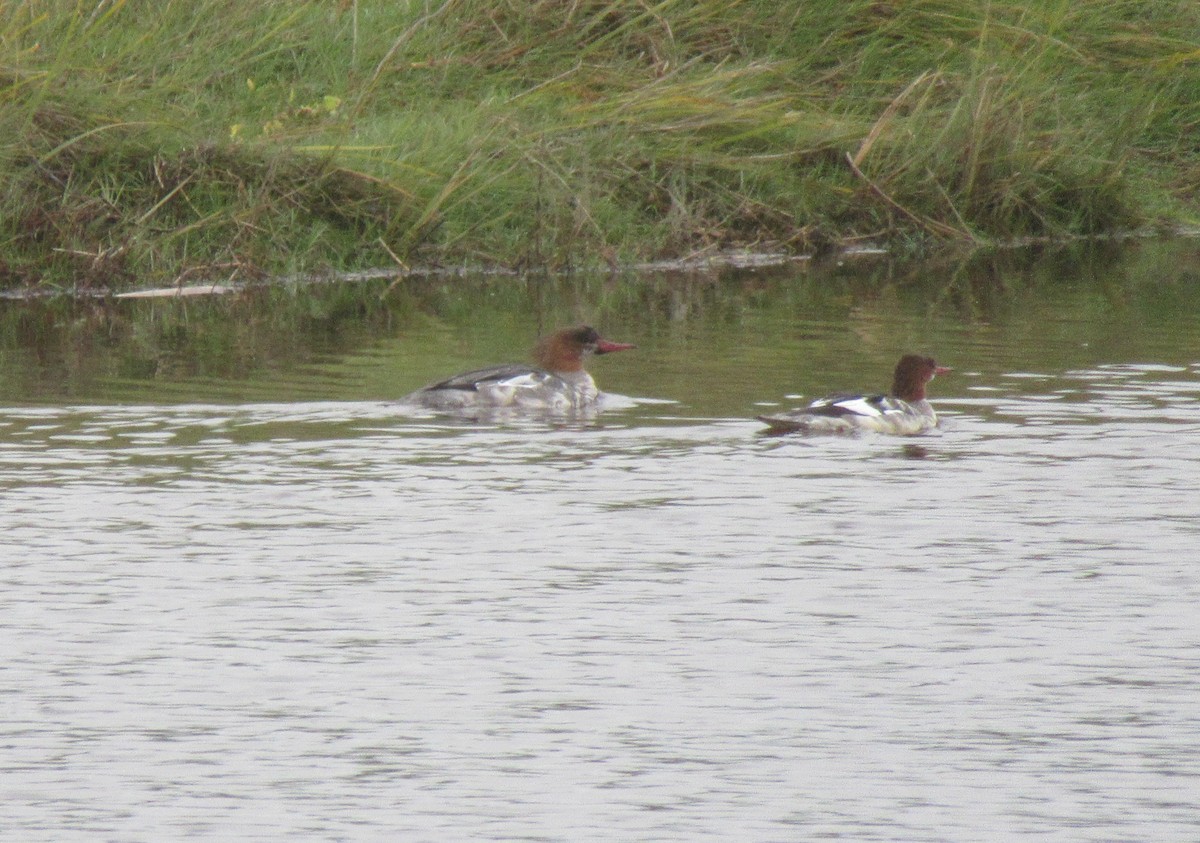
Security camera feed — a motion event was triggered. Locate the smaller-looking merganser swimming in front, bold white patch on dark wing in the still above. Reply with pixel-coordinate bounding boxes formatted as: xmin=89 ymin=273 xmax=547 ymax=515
xmin=758 ymin=354 xmax=950 ymax=436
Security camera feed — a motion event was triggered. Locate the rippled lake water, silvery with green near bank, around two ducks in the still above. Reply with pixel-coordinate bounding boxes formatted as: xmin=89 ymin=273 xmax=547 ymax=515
xmin=0 ymin=243 xmax=1200 ymax=842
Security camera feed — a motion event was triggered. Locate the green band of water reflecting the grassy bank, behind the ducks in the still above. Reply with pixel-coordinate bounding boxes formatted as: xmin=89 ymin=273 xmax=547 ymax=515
xmin=0 ymin=237 xmax=1200 ymax=415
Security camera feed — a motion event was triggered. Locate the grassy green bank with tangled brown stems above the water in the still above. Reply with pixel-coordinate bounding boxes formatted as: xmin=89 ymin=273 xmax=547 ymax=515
xmin=0 ymin=0 xmax=1200 ymax=287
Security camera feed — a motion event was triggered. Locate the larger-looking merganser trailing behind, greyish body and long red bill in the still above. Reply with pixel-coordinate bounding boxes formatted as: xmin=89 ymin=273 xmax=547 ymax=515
xmin=402 ymin=325 xmax=634 ymax=413
